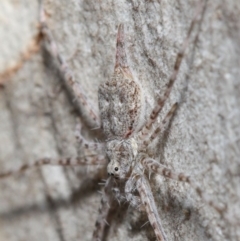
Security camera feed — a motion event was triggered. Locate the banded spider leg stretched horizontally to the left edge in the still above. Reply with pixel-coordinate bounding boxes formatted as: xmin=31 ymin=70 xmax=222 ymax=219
xmin=0 ymin=156 xmax=106 ymax=179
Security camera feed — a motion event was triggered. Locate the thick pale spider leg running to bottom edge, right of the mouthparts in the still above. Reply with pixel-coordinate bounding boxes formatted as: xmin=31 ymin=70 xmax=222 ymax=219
xmin=137 ymin=176 xmax=167 ymax=241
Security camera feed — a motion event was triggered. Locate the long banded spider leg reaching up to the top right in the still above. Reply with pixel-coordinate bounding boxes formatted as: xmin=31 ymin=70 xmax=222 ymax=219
xmin=138 ymin=2 xmax=204 ymax=139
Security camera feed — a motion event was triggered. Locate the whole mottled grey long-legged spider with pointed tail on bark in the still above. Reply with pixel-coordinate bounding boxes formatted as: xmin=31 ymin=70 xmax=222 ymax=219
xmin=0 ymin=0 xmax=222 ymax=241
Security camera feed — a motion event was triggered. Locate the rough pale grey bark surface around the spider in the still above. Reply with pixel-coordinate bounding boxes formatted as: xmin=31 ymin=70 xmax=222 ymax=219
xmin=0 ymin=0 xmax=240 ymax=241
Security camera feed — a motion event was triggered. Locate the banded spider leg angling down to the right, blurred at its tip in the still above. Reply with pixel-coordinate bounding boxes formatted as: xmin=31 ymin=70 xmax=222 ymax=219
xmin=141 ymin=158 xmax=226 ymax=213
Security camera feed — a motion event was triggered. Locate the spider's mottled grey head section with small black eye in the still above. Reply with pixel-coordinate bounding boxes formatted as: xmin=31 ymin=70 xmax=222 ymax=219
xmin=106 ymin=139 xmax=137 ymax=179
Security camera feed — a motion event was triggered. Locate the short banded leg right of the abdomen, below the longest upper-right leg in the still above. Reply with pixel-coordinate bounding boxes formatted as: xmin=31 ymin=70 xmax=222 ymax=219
xmin=142 ymin=103 xmax=178 ymax=148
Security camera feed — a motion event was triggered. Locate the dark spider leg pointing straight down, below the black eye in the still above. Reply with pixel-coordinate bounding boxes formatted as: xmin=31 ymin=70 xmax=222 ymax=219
xmin=92 ymin=177 xmax=114 ymax=241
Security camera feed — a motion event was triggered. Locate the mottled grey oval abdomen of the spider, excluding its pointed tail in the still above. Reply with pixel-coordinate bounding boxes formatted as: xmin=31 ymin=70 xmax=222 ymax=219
xmin=98 ymin=68 xmax=143 ymax=138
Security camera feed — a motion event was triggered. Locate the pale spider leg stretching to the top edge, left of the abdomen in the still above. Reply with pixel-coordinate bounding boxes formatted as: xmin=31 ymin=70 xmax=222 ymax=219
xmin=40 ymin=0 xmax=100 ymax=127
